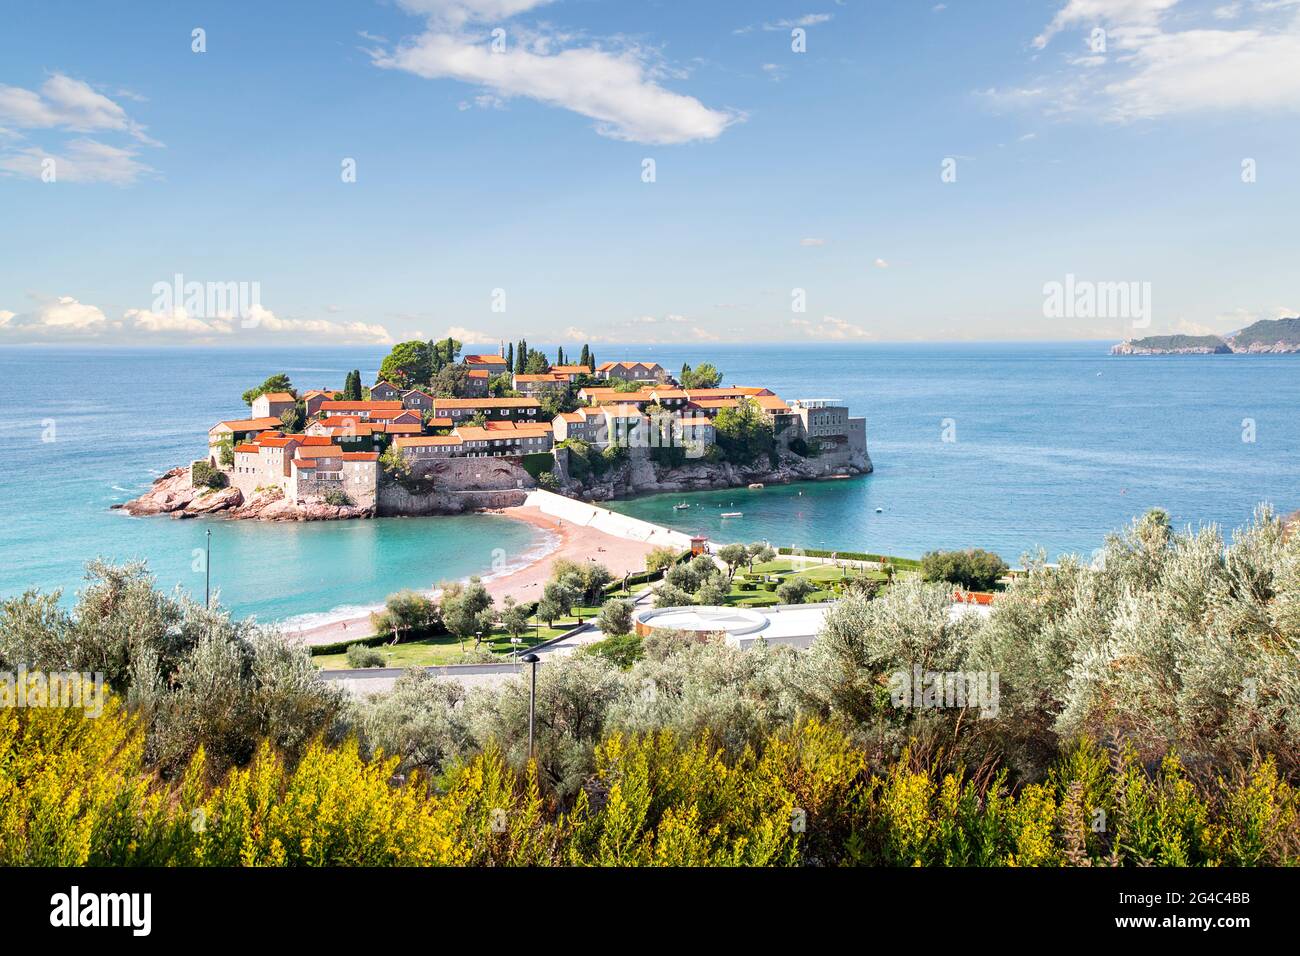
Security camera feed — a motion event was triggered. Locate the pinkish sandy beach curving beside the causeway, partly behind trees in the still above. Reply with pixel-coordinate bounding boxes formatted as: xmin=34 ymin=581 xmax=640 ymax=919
xmin=286 ymin=506 xmax=654 ymax=645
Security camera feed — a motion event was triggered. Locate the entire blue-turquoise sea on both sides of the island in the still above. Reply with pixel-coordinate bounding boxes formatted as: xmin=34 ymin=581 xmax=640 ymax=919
xmin=0 ymin=342 xmax=1300 ymax=620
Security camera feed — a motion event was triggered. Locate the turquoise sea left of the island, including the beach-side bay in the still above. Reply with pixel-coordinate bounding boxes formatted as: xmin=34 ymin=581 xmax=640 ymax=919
xmin=0 ymin=349 xmax=543 ymax=620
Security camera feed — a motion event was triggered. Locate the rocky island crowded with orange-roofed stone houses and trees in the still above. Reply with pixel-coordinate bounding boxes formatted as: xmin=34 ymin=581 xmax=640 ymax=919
xmin=122 ymin=338 xmax=872 ymax=520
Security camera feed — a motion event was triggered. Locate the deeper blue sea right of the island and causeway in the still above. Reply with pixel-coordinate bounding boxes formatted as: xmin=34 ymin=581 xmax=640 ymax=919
xmin=611 ymin=342 xmax=1300 ymax=562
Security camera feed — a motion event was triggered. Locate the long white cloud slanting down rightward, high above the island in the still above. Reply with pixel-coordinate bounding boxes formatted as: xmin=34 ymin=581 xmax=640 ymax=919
xmin=373 ymin=30 xmax=740 ymax=144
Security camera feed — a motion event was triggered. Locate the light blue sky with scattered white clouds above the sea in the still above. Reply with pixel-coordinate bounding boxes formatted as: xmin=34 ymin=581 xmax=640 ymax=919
xmin=0 ymin=0 xmax=1300 ymax=354
